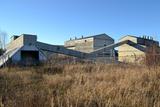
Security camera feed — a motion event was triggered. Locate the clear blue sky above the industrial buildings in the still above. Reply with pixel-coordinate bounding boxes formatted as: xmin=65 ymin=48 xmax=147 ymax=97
xmin=0 ymin=0 xmax=160 ymax=44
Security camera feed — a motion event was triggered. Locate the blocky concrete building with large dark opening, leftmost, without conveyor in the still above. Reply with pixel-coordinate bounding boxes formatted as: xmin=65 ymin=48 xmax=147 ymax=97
xmin=5 ymin=34 xmax=46 ymax=65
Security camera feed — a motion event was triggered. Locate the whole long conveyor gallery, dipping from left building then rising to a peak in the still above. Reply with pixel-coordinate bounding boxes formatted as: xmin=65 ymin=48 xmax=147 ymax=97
xmin=36 ymin=40 xmax=146 ymax=59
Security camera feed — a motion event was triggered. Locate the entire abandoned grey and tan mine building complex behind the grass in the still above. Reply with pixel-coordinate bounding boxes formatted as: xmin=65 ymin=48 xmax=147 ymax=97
xmin=0 ymin=34 xmax=159 ymax=66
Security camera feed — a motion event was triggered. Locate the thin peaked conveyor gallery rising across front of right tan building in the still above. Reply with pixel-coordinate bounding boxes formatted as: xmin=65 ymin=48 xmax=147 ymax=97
xmin=85 ymin=40 xmax=146 ymax=58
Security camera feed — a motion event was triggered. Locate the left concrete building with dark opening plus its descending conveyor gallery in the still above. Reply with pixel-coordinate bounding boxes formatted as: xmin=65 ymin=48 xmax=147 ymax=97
xmin=0 ymin=34 xmax=85 ymax=66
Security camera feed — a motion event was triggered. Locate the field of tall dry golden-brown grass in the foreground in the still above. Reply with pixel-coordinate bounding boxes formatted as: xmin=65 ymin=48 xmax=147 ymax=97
xmin=0 ymin=64 xmax=160 ymax=107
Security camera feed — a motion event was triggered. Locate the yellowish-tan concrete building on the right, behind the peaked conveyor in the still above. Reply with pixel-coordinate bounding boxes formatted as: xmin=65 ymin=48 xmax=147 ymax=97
xmin=118 ymin=35 xmax=159 ymax=63
